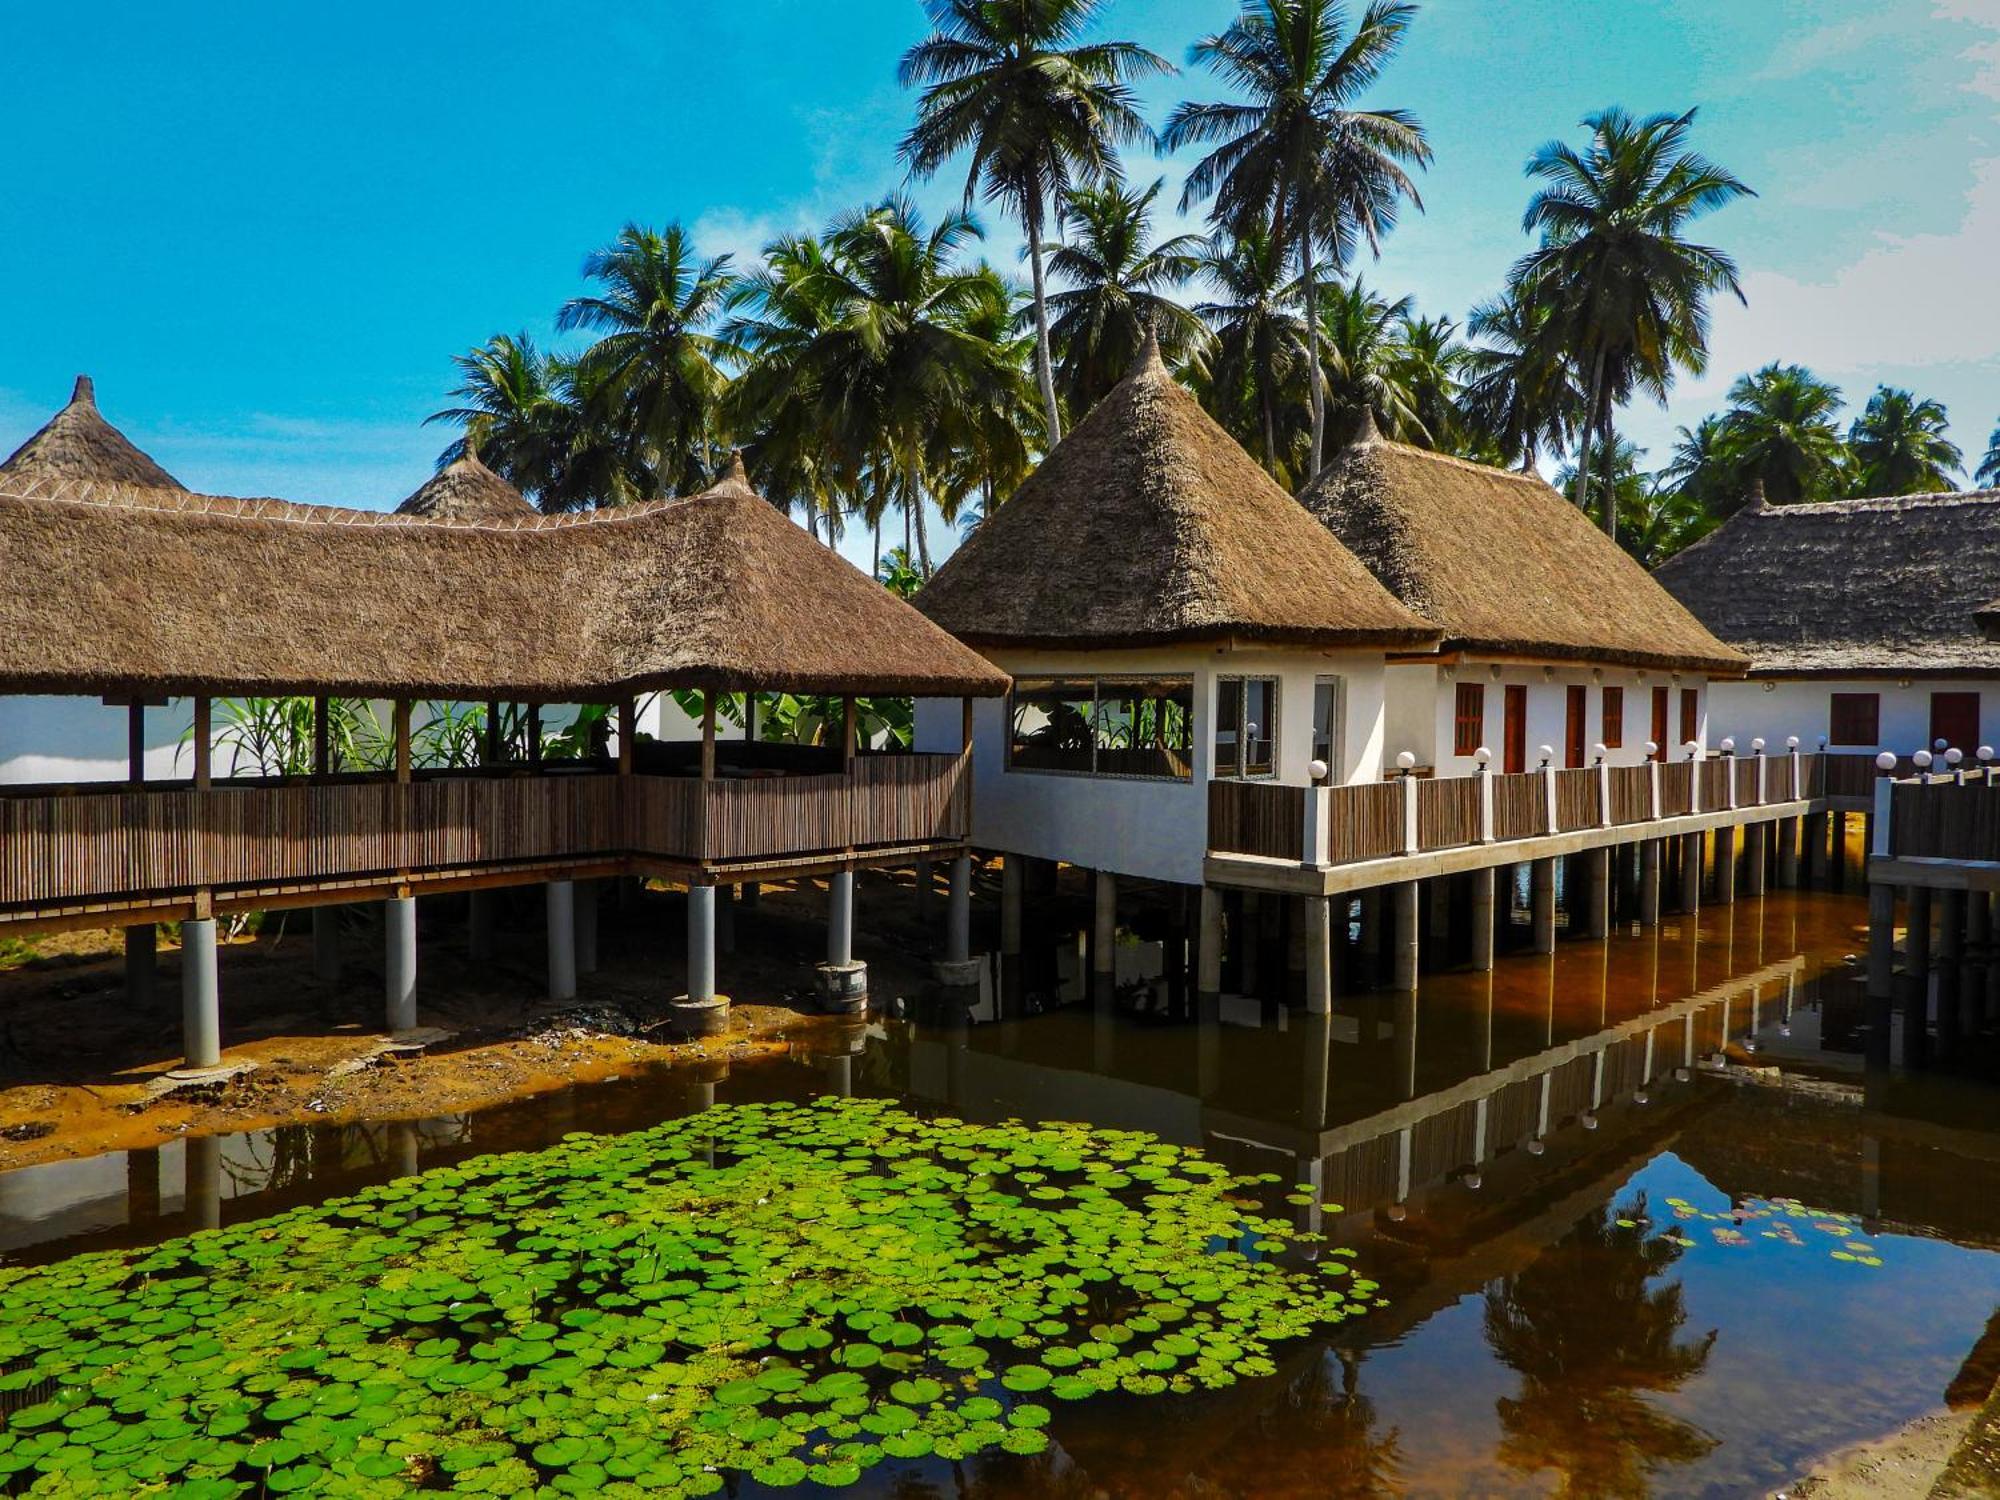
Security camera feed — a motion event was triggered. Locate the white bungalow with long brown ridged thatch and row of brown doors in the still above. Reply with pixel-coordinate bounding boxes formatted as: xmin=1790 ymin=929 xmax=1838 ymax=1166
xmin=1300 ymin=418 xmax=1748 ymax=774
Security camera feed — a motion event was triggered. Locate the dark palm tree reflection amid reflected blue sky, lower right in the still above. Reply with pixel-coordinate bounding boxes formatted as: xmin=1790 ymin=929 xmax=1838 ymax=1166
xmin=1486 ymin=1194 xmax=1718 ymax=1498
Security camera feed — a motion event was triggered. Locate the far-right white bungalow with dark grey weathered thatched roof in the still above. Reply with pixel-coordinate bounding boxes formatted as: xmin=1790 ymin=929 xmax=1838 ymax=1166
xmin=1656 ymin=490 xmax=2000 ymax=754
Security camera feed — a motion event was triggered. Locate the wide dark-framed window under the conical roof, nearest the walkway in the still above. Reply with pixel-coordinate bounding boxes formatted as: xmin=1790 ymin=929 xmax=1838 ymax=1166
xmin=1008 ymin=678 xmax=1194 ymax=780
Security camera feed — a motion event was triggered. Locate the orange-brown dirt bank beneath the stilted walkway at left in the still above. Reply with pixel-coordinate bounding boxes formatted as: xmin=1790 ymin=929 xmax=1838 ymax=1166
xmin=0 ymin=870 xmax=944 ymax=1170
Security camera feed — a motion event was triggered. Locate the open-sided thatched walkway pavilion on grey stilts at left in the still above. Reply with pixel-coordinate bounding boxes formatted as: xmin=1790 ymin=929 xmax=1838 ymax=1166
xmin=0 ymin=382 xmax=1006 ymax=1066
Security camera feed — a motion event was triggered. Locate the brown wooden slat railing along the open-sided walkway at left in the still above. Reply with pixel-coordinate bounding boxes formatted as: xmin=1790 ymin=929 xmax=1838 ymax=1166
xmin=0 ymin=754 xmax=968 ymax=908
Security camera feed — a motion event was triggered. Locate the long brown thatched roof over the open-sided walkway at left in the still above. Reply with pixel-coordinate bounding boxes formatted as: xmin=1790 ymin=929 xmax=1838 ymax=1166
xmin=0 ymin=480 xmax=1006 ymax=702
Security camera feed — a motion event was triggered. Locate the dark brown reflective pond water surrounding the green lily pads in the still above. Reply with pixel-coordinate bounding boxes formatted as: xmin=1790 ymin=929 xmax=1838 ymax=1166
xmin=0 ymin=894 xmax=2000 ymax=1500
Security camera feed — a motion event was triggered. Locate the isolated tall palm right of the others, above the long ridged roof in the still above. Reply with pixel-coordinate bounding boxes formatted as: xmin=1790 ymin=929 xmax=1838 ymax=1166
xmin=1510 ymin=108 xmax=1750 ymax=536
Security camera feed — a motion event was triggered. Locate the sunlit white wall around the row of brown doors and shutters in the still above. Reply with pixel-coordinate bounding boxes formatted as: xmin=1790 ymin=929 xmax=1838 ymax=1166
xmin=1384 ymin=656 xmax=1714 ymax=776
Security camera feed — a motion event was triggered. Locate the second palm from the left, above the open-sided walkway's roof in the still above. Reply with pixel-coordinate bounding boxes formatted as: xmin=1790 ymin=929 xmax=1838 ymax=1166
xmin=556 ymin=224 xmax=740 ymax=496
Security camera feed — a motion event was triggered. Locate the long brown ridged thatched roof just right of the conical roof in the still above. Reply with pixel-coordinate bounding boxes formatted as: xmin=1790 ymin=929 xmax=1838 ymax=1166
xmin=1300 ymin=422 xmax=1746 ymax=674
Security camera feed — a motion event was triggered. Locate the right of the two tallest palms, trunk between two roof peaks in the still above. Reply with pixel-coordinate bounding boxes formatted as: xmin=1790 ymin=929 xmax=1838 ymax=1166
xmin=1162 ymin=0 xmax=1430 ymax=478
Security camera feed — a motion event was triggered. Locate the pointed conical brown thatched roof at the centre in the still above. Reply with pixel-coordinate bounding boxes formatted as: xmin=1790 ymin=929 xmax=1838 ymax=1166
xmin=916 ymin=342 xmax=1436 ymax=650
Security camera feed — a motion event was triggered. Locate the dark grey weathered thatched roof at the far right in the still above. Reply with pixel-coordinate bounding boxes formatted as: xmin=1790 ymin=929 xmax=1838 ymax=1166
xmin=1656 ymin=490 xmax=2000 ymax=676
